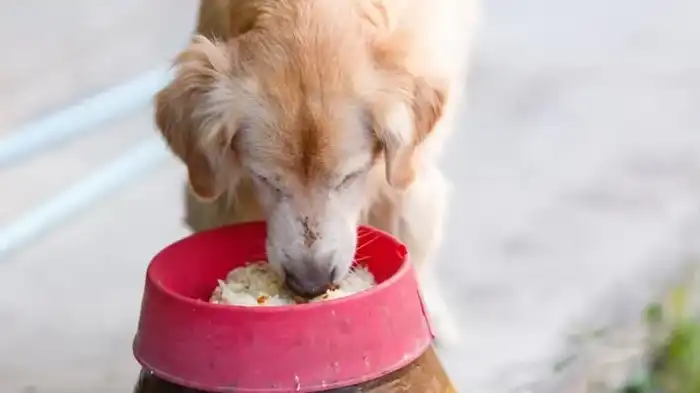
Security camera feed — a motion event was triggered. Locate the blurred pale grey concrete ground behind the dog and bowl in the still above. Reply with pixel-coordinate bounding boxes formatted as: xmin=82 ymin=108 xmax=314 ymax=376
xmin=0 ymin=0 xmax=700 ymax=393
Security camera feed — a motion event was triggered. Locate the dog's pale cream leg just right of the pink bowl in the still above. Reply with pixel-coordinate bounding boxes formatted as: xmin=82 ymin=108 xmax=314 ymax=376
xmin=396 ymin=166 xmax=461 ymax=345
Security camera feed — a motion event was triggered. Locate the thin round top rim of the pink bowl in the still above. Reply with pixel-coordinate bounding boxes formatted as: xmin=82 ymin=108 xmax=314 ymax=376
xmin=146 ymin=221 xmax=414 ymax=313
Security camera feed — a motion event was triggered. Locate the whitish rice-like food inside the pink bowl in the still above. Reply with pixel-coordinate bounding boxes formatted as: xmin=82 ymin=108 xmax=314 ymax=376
xmin=209 ymin=261 xmax=377 ymax=306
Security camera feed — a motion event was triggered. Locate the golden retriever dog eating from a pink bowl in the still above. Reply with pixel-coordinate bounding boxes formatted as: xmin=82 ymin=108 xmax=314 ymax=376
xmin=156 ymin=0 xmax=477 ymax=340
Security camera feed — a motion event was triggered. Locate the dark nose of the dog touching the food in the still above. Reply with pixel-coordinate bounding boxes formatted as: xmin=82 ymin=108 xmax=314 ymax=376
xmin=285 ymin=261 xmax=335 ymax=299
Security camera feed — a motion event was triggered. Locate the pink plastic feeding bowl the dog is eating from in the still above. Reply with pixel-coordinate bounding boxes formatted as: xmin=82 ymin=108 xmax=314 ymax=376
xmin=134 ymin=223 xmax=433 ymax=393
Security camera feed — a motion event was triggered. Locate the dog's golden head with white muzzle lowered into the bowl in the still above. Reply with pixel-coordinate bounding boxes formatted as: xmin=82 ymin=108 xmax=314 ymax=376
xmin=156 ymin=2 xmax=443 ymax=295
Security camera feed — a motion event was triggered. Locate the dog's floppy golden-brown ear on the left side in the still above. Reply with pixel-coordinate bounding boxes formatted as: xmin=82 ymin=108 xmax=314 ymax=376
xmin=155 ymin=36 xmax=238 ymax=200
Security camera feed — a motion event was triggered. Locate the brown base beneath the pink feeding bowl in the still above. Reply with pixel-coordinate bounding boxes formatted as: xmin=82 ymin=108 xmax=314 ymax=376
xmin=134 ymin=348 xmax=456 ymax=393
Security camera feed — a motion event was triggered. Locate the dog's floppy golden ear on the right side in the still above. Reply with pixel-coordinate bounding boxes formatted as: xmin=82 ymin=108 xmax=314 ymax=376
xmin=373 ymin=77 xmax=446 ymax=189
